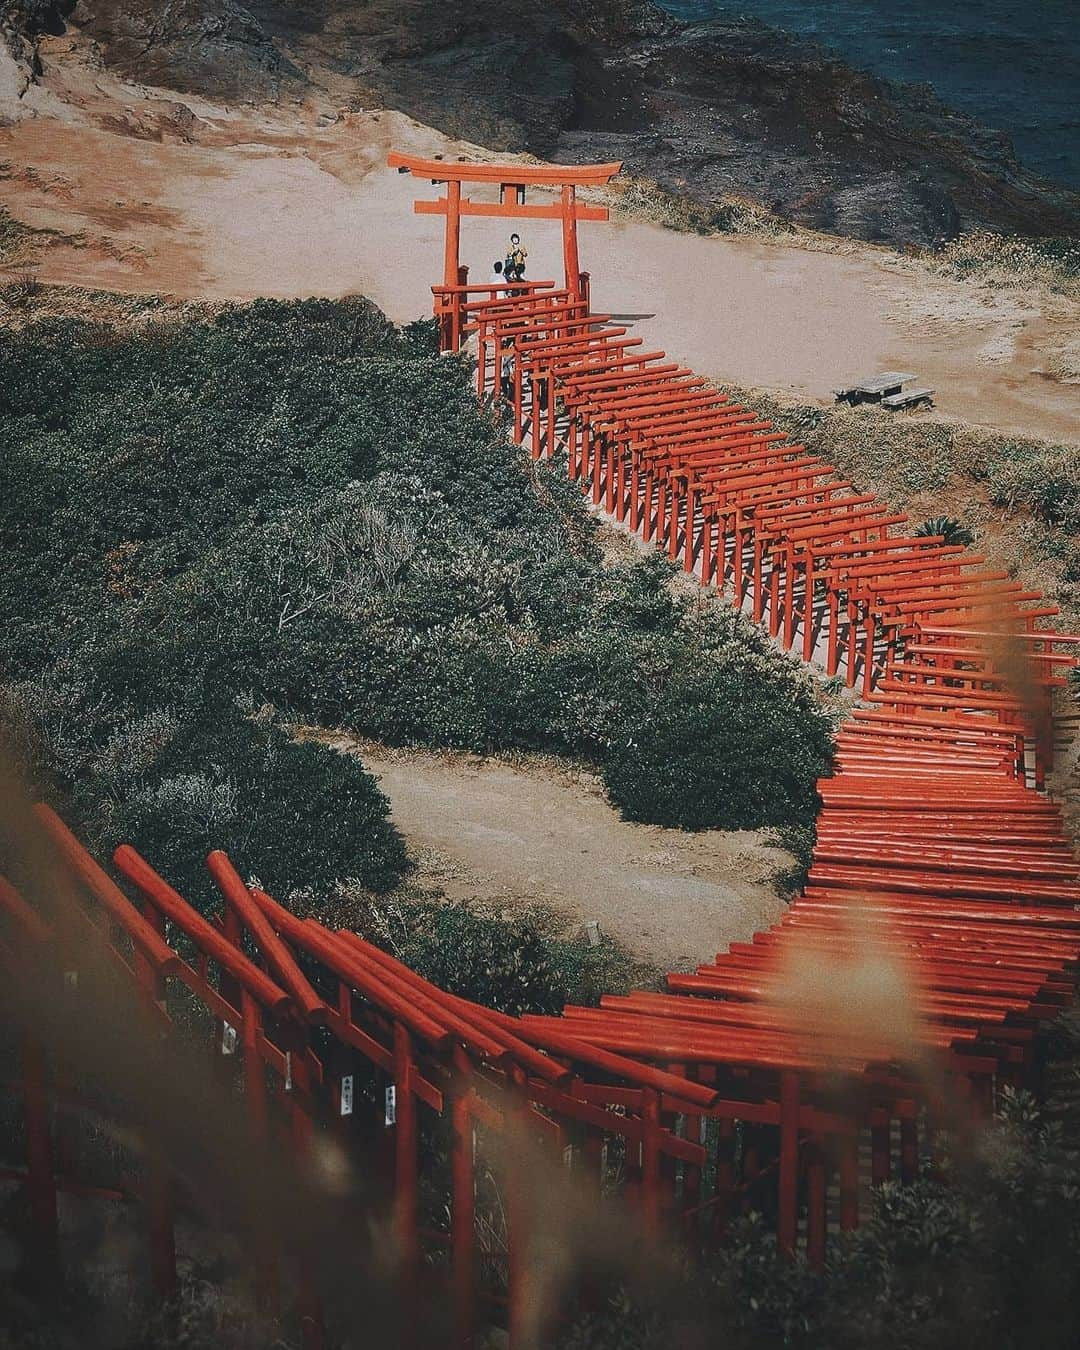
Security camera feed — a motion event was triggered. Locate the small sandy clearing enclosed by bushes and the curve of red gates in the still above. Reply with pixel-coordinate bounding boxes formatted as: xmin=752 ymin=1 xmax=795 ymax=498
xmin=329 ymin=737 xmax=791 ymax=971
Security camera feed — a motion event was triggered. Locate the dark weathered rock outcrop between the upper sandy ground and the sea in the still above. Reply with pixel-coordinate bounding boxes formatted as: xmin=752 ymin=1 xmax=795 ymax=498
xmin=8 ymin=0 xmax=1080 ymax=243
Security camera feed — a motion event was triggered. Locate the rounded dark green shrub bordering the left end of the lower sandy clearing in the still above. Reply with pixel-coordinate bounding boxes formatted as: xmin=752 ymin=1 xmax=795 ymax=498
xmin=0 ymin=672 xmax=408 ymax=909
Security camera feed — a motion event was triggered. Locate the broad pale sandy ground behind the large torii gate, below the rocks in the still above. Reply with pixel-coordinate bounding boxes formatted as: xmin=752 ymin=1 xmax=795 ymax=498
xmin=0 ymin=38 xmax=1080 ymax=437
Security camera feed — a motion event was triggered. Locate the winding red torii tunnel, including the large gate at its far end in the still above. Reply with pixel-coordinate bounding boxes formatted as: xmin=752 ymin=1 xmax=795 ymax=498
xmin=0 ymin=155 xmax=1080 ymax=1350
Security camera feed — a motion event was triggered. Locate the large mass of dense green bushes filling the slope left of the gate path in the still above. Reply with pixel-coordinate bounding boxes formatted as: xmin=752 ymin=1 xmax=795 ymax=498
xmin=0 ymin=300 xmax=830 ymax=918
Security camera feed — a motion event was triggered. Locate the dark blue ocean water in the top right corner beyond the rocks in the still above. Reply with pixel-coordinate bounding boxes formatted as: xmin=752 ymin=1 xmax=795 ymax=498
xmin=659 ymin=0 xmax=1080 ymax=188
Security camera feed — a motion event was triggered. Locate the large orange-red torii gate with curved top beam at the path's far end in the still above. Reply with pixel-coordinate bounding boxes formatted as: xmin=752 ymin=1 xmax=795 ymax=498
xmin=386 ymin=153 xmax=622 ymax=296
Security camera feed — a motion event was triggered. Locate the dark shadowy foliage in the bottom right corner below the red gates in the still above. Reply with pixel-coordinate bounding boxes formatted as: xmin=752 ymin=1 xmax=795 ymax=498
xmin=560 ymin=1074 xmax=1080 ymax=1350
